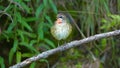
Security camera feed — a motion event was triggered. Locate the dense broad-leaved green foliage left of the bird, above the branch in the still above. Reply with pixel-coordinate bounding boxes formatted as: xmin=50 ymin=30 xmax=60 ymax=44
xmin=0 ymin=0 xmax=57 ymax=67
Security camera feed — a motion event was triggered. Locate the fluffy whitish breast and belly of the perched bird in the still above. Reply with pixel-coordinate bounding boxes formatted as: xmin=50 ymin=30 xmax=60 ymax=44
xmin=52 ymin=23 xmax=72 ymax=40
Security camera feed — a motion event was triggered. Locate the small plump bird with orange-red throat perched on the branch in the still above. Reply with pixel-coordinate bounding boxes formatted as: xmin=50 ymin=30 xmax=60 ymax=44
xmin=51 ymin=13 xmax=72 ymax=41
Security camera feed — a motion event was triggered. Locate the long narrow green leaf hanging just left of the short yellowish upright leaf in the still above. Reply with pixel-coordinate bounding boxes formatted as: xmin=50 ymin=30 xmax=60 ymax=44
xmin=9 ymin=39 xmax=18 ymax=64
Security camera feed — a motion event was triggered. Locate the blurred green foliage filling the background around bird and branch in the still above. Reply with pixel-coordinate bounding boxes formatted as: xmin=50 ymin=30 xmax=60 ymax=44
xmin=0 ymin=0 xmax=120 ymax=68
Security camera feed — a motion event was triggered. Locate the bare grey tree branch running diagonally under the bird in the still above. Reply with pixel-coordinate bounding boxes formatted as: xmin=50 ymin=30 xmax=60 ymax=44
xmin=10 ymin=30 xmax=120 ymax=68
